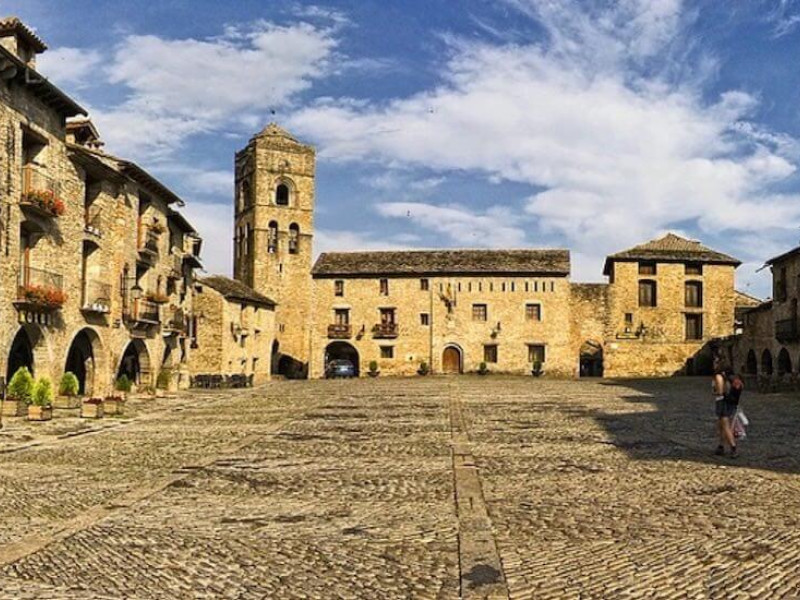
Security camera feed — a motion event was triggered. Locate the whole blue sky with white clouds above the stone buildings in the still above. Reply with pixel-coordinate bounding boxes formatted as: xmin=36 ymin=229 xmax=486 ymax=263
xmin=6 ymin=0 xmax=800 ymax=296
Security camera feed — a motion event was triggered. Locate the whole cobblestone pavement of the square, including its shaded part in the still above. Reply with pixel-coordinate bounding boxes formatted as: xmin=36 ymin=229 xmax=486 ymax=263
xmin=0 ymin=377 xmax=800 ymax=600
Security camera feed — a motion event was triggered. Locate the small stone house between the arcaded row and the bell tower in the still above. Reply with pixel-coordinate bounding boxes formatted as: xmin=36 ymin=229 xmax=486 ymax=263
xmin=191 ymin=275 xmax=275 ymax=385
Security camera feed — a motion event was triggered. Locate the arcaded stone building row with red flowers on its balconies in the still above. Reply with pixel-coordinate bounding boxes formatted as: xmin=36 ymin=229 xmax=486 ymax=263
xmin=0 ymin=18 xmax=200 ymax=394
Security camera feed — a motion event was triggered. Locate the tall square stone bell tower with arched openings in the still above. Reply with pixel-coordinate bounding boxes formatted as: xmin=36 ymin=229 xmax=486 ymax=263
xmin=233 ymin=123 xmax=315 ymax=376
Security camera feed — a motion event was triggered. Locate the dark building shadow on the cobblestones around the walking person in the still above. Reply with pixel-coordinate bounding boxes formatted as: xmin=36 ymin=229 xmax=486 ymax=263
xmin=592 ymin=377 xmax=800 ymax=473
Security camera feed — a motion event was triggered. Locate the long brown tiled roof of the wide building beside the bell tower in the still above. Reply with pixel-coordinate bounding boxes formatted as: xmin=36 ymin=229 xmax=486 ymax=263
xmin=311 ymin=250 xmax=570 ymax=277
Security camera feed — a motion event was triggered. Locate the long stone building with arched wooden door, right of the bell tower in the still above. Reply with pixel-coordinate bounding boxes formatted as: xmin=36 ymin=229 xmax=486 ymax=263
xmin=310 ymin=250 xmax=574 ymax=377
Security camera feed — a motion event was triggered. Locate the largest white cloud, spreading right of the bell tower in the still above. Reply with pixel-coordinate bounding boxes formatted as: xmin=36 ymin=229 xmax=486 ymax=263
xmin=291 ymin=0 xmax=800 ymax=270
